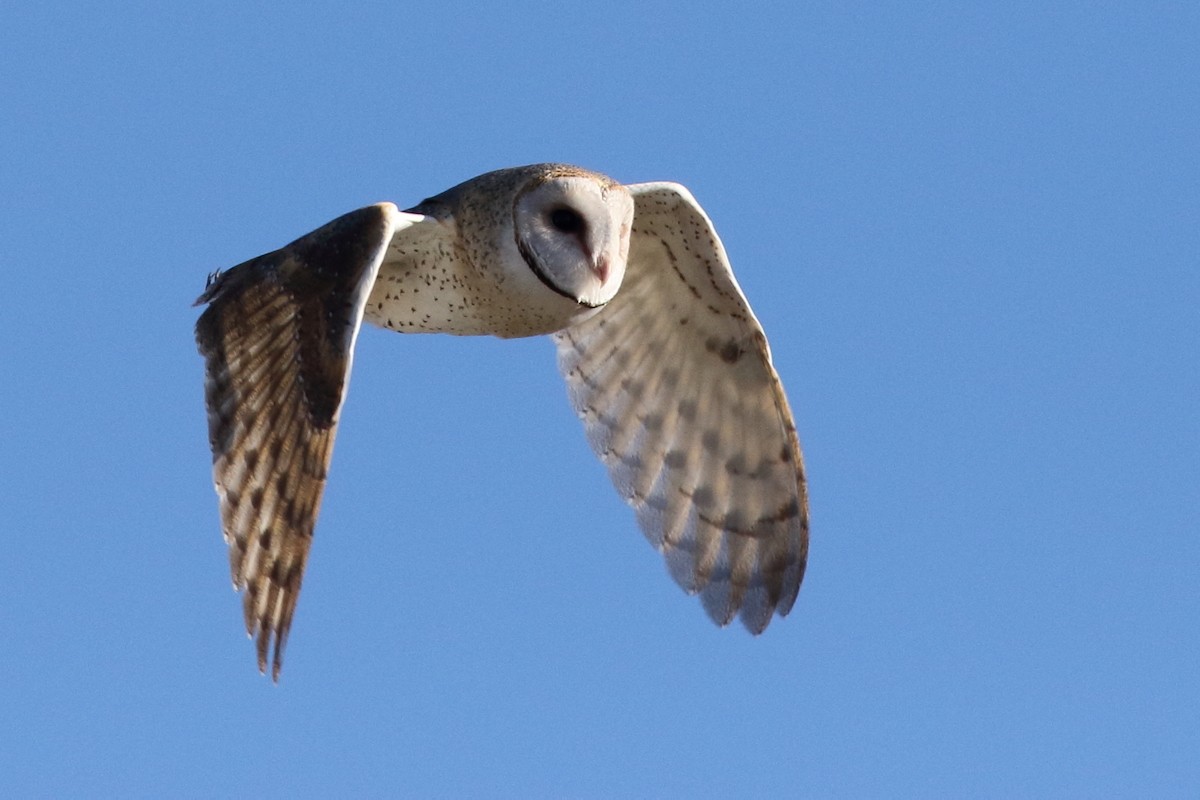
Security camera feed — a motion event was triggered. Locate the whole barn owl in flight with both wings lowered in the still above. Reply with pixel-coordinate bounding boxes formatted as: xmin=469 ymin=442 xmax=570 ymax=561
xmin=196 ymin=164 xmax=809 ymax=680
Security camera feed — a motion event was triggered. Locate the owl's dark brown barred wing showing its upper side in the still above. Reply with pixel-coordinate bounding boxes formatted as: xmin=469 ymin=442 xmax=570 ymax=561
xmin=196 ymin=204 xmax=395 ymax=680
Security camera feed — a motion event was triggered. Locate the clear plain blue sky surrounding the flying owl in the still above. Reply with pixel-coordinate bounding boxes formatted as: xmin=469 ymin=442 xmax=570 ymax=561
xmin=0 ymin=0 xmax=1200 ymax=798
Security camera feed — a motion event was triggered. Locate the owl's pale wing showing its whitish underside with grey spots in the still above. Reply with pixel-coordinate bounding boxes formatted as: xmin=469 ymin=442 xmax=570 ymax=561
xmin=554 ymin=184 xmax=809 ymax=633
